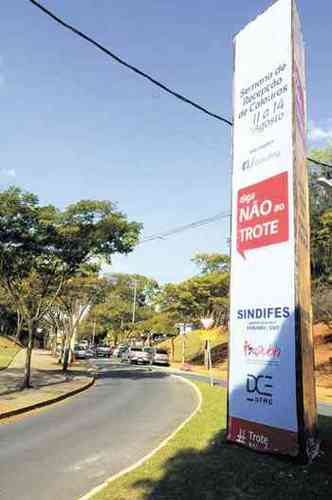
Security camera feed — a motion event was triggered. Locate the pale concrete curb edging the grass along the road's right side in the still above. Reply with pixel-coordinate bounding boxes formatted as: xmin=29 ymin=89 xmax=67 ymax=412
xmin=78 ymin=374 xmax=203 ymax=500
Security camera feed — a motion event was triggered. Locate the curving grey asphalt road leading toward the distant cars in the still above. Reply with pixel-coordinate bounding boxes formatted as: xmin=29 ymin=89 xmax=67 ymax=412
xmin=0 ymin=361 xmax=197 ymax=500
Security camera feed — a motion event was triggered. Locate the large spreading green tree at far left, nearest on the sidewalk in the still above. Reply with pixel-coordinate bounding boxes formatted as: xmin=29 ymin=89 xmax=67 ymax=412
xmin=0 ymin=187 xmax=141 ymax=387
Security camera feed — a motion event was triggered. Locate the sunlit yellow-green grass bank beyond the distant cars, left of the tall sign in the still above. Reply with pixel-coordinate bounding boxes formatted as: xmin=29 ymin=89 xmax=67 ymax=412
xmin=158 ymin=329 xmax=227 ymax=363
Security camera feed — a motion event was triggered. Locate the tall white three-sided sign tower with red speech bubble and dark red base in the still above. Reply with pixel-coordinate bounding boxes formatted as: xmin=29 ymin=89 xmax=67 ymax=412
xmin=227 ymin=0 xmax=315 ymax=456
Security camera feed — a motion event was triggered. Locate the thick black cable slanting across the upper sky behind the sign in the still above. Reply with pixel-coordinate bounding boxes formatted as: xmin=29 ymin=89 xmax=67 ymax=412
xmin=28 ymin=0 xmax=332 ymax=168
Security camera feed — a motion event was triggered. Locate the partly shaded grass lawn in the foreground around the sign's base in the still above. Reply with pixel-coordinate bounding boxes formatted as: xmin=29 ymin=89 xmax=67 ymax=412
xmin=95 ymin=383 xmax=332 ymax=500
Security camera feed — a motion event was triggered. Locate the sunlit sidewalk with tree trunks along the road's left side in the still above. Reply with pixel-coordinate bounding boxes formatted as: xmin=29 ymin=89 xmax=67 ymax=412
xmin=0 ymin=349 xmax=94 ymax=419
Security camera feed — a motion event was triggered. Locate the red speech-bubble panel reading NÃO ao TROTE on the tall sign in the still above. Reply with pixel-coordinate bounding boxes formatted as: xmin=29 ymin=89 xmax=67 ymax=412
xmin=236 ymin=172 xmax=289 ymax=258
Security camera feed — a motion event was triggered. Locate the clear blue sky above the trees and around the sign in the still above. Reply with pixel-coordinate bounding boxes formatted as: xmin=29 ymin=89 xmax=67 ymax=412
xmin=0 ymin=0 xmax=332 ymax=282
